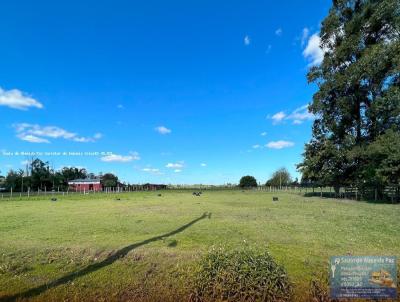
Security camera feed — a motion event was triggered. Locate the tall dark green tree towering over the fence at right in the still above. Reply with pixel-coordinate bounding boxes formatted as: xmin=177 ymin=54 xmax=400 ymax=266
xmin=299 ymin=0 xmax=400 ymax=192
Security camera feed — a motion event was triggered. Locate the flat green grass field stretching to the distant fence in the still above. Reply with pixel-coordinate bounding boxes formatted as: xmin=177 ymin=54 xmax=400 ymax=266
xmin=0 ymin=190 xmax=400 ymax=301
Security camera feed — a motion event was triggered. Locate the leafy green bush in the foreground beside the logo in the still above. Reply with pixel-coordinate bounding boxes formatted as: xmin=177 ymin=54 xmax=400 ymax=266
xmin=191 ymin=248 xmax=292 ymax=301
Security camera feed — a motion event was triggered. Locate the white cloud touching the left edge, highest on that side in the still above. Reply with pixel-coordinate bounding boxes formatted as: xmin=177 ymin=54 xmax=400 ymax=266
xmin=0 ymin=87 xmax=43 ymax=110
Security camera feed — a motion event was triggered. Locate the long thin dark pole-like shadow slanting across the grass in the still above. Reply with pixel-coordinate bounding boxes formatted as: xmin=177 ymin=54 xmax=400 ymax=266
xmin=0 ymin=212 xmax=211 ymax=301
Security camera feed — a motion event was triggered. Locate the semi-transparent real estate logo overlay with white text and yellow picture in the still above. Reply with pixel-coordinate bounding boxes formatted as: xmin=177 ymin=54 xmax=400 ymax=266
xmin=329 ymin=256 xmax=397 ymax=299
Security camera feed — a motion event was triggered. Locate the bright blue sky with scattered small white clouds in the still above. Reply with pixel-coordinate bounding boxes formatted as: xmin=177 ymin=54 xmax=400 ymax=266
xmin=0 ymin=0 xmax=331 ymax=184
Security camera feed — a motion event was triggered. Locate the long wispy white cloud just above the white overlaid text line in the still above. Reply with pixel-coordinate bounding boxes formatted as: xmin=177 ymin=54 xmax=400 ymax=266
xmin=13 ymin=123 xmax=102 ymax=143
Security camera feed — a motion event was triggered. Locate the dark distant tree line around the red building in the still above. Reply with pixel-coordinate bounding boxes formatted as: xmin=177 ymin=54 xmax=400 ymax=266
xmin=0 ymin=158 xmax=119 ymax=192
